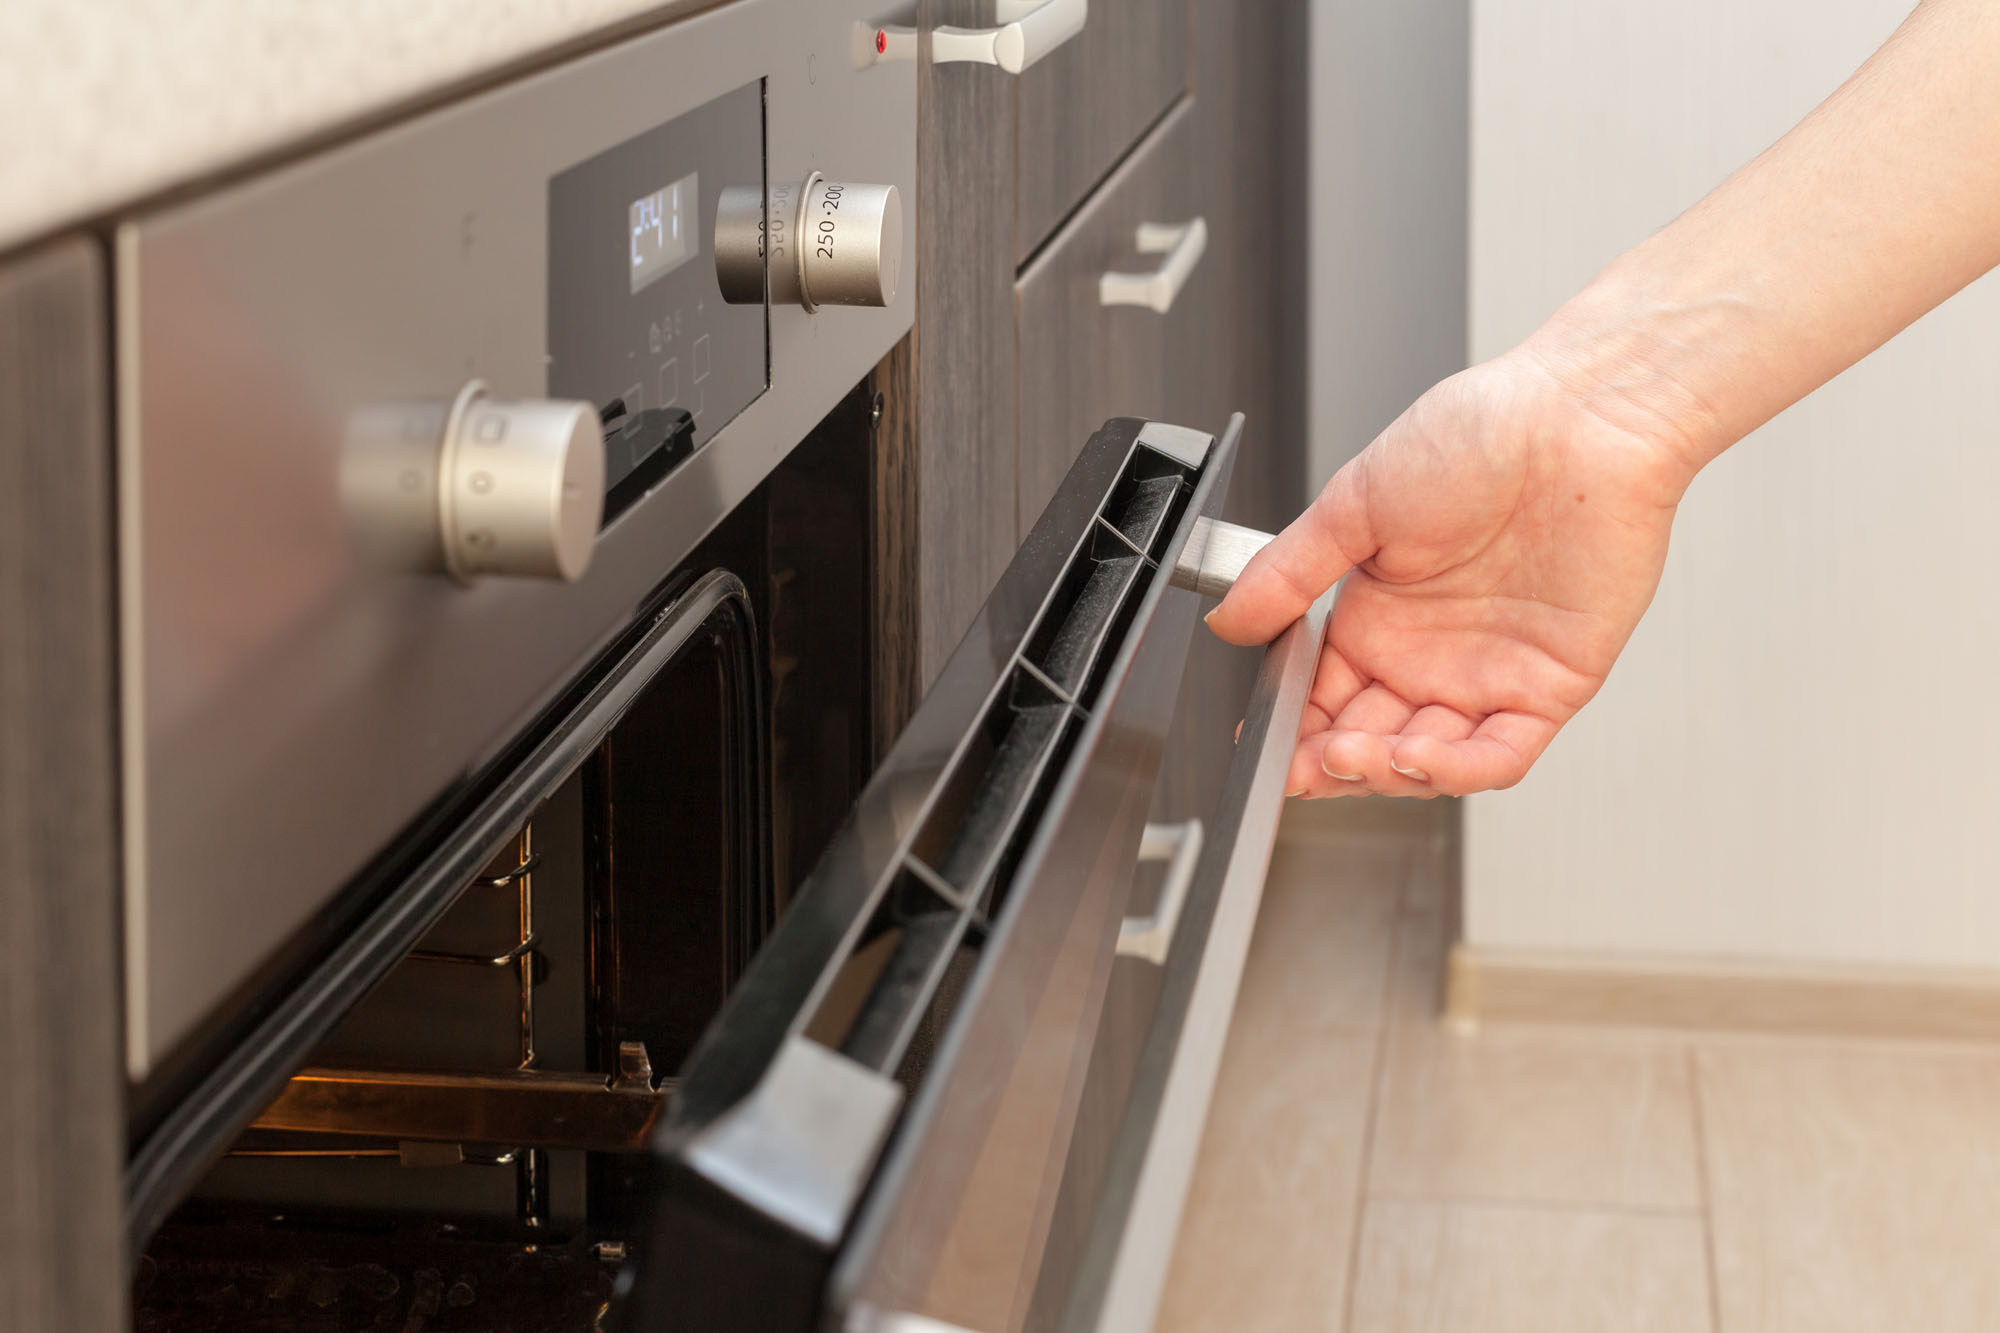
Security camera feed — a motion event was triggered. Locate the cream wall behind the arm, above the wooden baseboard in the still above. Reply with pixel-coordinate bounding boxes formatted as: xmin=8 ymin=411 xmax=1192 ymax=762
xmin=1466 ymin=0 xmax=2000 ymax=967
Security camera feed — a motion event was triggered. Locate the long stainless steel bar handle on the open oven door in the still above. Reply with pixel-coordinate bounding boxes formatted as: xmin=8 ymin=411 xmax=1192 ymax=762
xmin=1062 ymin=580 xmax=1334 ymax=1333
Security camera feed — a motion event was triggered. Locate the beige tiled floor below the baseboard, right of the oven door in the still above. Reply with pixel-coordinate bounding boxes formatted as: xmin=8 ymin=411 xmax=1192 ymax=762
xmin=1158 ymin=801 xmax=2000 ymax=1333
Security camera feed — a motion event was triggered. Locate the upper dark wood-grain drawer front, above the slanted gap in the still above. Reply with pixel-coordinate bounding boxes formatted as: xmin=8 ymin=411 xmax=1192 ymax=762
xmin=1014 ymin=0 xmax=1188 ymax=264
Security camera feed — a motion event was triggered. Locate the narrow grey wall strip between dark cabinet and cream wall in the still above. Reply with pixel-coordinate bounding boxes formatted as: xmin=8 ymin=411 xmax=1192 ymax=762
xmin=1306 ymin=0 xmax=1468 ymax=494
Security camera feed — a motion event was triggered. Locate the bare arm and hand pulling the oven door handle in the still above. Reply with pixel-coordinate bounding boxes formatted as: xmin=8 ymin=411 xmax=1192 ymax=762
xmin=1210 ymin=0 xmax=2000 ymax=795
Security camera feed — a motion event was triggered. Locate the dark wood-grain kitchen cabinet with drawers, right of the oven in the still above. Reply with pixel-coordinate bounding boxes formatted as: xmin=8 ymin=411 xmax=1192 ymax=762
xmin=908 ymin=0 xmax=1306 ymax=1329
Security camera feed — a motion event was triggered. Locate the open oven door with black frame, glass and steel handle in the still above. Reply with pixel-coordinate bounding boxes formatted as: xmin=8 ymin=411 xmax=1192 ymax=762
xmin=612 ymin=418 xmax=1332 ymax=1333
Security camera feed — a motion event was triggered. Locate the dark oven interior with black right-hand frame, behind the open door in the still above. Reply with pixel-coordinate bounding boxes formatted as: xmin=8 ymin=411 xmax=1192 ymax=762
xmin=132 ymin=384 xmax=874 ymax=1333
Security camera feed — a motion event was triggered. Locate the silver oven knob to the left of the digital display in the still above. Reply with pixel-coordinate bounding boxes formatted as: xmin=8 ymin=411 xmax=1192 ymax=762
xmin=438 ymin=380 xmax=604 ymax=582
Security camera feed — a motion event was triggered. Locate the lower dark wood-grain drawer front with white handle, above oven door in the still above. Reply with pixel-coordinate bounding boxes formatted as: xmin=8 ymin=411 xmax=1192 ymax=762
xmin=1014 ymin=94 xmax=1222 ymax=536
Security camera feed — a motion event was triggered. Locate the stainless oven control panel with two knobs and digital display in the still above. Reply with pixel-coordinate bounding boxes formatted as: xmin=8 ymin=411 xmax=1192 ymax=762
xmin=116 ymin=0 xmax=916 ymax=1079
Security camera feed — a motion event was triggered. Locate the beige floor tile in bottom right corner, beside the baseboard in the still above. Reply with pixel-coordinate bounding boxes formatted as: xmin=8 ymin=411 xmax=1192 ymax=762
xmin=1696 ymin=1043 xmax=2000 ymax=1333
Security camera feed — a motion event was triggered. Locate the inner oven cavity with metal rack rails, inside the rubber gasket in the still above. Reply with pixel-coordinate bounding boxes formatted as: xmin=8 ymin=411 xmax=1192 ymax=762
xmin=136 ymin=572 xmax=776 ymax=1296
